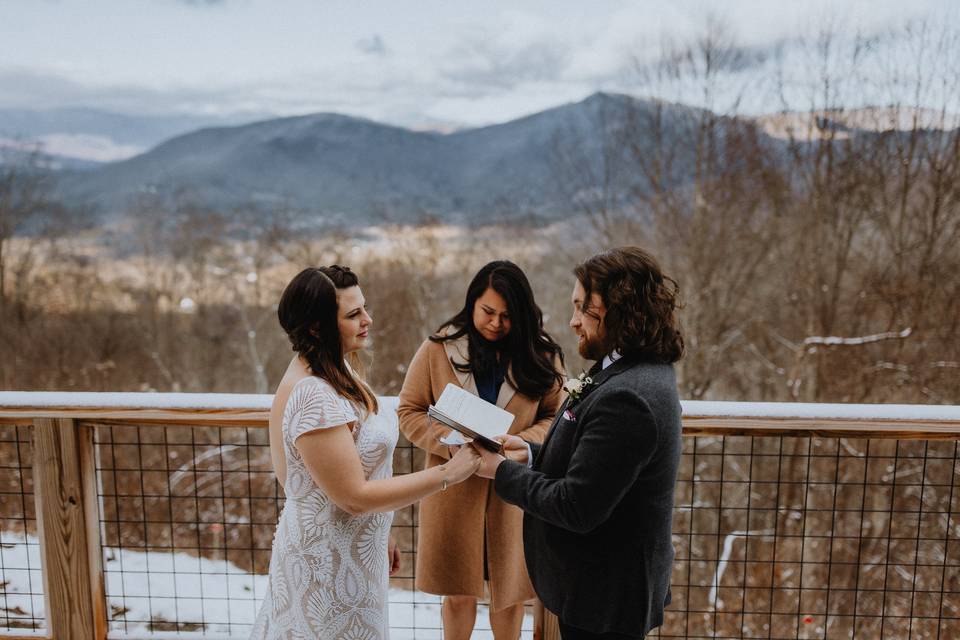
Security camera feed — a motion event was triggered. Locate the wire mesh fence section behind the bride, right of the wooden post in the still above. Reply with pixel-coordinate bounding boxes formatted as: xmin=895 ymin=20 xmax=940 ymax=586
xmin=95 ymin=425 xmax=532 ymax=640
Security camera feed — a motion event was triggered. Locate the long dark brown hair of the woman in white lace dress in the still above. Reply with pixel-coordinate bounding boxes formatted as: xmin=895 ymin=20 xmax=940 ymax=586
xmin=277 ymin=264 xmax=379 ymax=413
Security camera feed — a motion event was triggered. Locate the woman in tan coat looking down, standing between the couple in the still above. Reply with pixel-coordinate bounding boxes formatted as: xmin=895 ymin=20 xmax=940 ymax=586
xmin=397 ymin=260 xmax=565 ymax=640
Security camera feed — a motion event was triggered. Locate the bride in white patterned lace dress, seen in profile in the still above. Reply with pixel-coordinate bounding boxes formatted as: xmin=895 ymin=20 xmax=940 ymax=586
xmin=251 ymin=265 xmax=480 ymax=640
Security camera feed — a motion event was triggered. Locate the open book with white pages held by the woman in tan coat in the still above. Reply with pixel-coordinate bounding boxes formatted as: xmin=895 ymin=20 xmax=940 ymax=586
xmin=427 ymin=384 xmax=513 ymax=453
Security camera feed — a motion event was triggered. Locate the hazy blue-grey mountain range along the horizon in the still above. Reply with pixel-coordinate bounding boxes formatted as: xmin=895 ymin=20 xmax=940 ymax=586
xmin=13 ymin=93 xmax=952 ymax=224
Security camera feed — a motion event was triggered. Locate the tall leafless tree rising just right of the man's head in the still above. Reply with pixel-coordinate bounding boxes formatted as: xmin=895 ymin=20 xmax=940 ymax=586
xmin=628 ymin=20 xmax=787 ymax=398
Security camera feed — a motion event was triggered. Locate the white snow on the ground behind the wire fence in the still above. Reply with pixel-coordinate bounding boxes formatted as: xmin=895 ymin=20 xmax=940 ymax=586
xmin=0 ymin=532 xmax=533 ymax=640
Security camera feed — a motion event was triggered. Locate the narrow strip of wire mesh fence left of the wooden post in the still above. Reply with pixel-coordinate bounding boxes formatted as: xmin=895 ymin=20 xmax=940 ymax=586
xmin=0 ymin=425 xmax=45 ymax=629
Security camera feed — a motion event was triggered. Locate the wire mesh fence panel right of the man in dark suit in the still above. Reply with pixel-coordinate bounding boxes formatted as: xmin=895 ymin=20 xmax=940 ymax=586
xmin=654 ymin=436 xmax=960 ymax=639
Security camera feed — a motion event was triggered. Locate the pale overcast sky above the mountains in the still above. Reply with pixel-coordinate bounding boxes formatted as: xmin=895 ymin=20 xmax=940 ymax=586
xmin=0 ymin=0 xmax=956 ymax=126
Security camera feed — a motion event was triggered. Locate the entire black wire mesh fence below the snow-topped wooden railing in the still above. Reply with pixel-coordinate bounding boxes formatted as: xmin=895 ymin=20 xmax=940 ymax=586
xmin=0 ymin=416 xmax=960 ymax=640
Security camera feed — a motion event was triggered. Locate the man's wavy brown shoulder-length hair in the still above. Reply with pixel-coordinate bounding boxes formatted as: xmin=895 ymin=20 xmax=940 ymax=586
xmin=573 ymin=247 xmax=684 ymax=363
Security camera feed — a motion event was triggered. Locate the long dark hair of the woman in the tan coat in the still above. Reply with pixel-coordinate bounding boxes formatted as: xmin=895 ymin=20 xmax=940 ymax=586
xmin=430 ymin=260 xmax=564 ymax=398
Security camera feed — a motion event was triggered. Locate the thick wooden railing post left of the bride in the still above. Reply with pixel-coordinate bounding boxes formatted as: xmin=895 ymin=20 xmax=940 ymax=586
xmin=33 ymin=418 xmax=106 ymax=640
